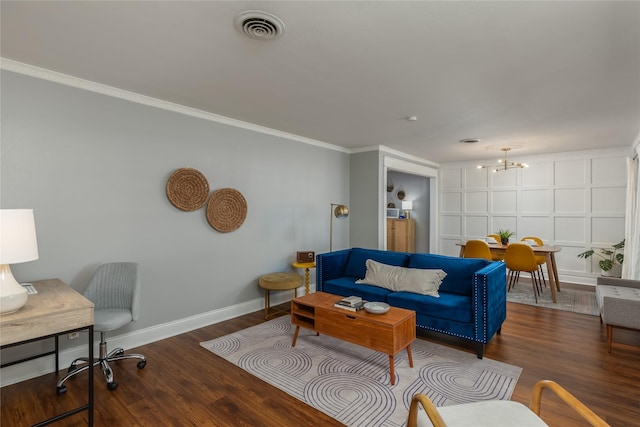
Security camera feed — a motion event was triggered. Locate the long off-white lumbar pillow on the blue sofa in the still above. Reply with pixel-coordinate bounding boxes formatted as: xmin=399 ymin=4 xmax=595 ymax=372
xmin=356 ymin=259 xmax=447 ymax=298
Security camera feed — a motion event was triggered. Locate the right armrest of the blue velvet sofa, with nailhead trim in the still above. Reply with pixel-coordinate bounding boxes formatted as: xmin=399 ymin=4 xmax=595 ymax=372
xmin=473 ymin=262 xmax=507 ymax=343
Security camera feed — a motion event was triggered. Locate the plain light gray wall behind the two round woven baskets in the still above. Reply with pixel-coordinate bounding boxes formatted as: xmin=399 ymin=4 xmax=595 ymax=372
xmin=0 ymin=71 xmax=351 ymax=332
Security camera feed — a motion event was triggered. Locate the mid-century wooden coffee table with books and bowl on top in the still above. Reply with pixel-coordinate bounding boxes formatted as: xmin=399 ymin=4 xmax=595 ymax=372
xmin=291 ymin=292 xmax=416 ymax=385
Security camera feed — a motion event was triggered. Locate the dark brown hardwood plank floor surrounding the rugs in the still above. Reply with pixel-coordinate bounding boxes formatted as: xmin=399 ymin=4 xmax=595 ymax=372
xmin=0 ymin=285 xmax=640 ymax=427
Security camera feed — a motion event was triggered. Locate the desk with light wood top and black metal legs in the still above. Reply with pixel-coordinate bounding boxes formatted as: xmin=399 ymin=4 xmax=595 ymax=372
xmin=0 ymin=279 xmax=93 ymax=426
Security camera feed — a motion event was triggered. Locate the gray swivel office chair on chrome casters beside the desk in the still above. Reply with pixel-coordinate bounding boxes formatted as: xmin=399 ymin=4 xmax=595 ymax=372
xmin=56 ymin=262 xmax=147 ymax=395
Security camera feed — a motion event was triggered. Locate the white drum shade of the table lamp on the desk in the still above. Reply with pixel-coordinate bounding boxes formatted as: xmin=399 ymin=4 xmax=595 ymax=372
xmin=0 ymin=209 xmax=38 ymax=264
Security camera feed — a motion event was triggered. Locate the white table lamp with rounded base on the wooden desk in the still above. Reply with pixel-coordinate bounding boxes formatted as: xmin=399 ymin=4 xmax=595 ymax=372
xmin=0 ymin=209 xmax=38 ymax=314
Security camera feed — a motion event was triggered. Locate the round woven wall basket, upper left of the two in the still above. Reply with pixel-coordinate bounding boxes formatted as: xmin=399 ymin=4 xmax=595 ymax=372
xmin=167 ymin=168 xmax=209 ymax=211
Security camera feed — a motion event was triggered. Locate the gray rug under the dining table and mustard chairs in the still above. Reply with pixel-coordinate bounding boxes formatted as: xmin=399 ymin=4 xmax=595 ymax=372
xmin=507 ymin=280 xmax=599 ymax=316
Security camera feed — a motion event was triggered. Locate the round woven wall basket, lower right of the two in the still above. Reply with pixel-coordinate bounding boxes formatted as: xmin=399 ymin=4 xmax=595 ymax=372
xmin=207 ymin=188 xmax=247 ymax=233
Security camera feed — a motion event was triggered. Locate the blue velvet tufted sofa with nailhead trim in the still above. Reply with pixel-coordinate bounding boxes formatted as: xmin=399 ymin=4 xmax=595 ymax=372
xmin=316 ymin=248 xmax=507 ymax=359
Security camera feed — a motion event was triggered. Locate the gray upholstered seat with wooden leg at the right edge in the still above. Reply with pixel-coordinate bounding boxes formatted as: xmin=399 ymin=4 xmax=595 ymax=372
xmin=596 ymin=276 xmax=640 ymax=353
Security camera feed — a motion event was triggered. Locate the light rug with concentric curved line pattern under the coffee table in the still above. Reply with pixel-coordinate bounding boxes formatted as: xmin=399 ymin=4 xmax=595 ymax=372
xmin=200 ymin=316 xmax=522 ymax=427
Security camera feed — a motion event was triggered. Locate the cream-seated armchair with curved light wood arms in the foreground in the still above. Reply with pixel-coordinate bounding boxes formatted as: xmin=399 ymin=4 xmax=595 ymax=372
xmin=407 ymin=380 xmax=609 ymax=427
